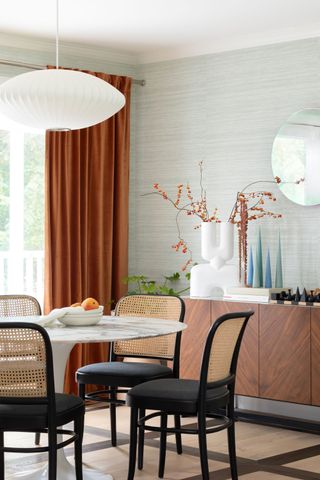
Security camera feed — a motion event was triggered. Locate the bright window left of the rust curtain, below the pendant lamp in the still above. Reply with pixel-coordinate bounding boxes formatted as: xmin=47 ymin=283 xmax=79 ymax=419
xmin=0 ymin=117 xmax=45 ymax=304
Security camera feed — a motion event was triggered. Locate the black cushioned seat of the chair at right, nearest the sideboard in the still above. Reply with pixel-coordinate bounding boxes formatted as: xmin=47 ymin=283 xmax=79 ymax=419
xmin=127 ymin=378 xmax=229 ymax=414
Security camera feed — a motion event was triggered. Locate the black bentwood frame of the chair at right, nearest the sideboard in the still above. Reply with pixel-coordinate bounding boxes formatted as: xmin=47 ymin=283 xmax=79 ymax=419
xmin=128 ymin=311 xmax=254 ymax=480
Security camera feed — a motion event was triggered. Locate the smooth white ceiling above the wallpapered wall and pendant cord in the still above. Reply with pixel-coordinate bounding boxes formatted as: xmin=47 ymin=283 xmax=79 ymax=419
xmin=0 ymin=0 xmax=320 ymax=63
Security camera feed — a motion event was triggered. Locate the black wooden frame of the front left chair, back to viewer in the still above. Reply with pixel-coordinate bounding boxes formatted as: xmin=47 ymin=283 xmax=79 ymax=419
xmin=0 ymin=322 xmax=84 ymax=480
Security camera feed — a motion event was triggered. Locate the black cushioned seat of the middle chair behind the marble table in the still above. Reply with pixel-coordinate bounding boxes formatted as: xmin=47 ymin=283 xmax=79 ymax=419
xmin=77 ymin=362 xmax=173 ymax=387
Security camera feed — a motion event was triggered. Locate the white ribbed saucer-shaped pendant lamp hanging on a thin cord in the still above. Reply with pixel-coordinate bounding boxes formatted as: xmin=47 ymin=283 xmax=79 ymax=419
xmin=0 ymin=0 xmax=125 ymax=131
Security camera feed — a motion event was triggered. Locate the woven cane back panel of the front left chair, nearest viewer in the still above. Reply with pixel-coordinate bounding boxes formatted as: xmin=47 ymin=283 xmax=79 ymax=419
xmin=0 ymin=324 xmax=47 ymax=399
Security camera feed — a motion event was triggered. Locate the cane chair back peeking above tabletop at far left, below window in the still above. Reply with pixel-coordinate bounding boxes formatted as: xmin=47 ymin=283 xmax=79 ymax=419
xmin=0 ymin=295 xmax=41 ymax=317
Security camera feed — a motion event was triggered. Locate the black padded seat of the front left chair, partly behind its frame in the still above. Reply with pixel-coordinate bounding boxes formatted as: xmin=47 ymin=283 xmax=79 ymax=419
xmin=0 ymin=393 xmax=84 ymax=431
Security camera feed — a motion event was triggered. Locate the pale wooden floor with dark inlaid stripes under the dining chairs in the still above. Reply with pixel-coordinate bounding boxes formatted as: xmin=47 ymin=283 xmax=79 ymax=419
xmin=6 ymin=407 xmax=320 ymax=480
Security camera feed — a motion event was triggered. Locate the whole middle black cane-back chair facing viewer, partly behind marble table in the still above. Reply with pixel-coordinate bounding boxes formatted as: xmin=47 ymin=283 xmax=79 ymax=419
xmin=76 ymin=295 xmax=185 ymax=469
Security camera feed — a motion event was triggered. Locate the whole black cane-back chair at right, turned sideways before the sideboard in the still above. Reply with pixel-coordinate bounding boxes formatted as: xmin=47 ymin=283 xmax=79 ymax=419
xmin=127 ymin=312 xmax=253 ymax=480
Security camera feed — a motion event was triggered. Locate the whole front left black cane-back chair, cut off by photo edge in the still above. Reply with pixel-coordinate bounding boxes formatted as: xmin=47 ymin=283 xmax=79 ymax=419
xmin=0 ymin=322 xmax=84 ymax=480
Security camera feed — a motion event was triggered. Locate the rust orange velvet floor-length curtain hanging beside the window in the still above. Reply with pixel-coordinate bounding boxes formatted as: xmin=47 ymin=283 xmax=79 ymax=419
xmin=44 ymin=71 xmax=131 ymax=393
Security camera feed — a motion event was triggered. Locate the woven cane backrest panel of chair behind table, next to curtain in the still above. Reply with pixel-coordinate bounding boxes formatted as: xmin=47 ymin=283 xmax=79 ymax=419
xmin=113 ymin=295 xmax=184 ymax=360
